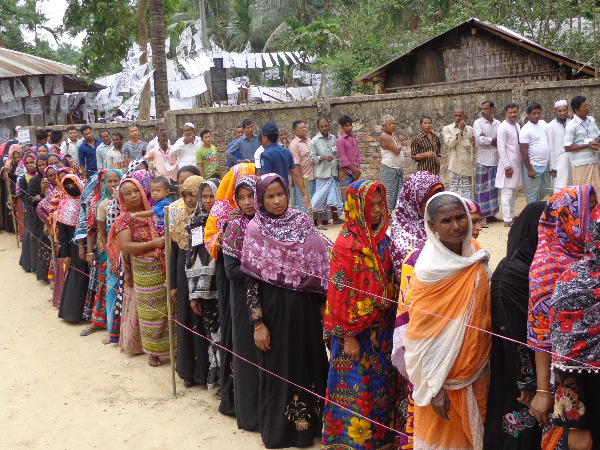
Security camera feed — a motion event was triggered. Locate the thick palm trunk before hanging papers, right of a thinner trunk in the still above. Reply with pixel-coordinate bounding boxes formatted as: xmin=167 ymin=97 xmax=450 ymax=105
xmin=150 ymin=0 xmax=169 ymax=118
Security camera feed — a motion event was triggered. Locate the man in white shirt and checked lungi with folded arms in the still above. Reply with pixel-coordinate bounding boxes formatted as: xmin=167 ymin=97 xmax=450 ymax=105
xmin=473 ymin=100 xmax=500 ymax=228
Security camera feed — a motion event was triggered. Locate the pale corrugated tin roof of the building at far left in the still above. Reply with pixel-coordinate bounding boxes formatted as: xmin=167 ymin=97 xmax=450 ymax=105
xmin=0 ymin=48 xmax=76 ymax=78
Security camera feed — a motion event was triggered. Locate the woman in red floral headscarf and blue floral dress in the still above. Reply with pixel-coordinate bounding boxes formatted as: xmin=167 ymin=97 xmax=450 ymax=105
xmin=321 ymin=180 xmax=398 ymax=450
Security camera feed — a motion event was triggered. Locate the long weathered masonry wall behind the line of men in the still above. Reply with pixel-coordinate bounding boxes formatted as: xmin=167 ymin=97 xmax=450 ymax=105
xmin=34 ymin=79 xmax=600 ymax=185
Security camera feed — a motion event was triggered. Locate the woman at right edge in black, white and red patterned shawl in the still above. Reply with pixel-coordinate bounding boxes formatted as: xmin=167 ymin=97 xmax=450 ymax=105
xmin=550 ymin=208 xmax=600 ymax=450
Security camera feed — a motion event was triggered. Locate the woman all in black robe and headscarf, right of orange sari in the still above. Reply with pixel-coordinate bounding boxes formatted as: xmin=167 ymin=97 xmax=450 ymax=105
xmin=483 ymin=202 xmax=546 ymax=449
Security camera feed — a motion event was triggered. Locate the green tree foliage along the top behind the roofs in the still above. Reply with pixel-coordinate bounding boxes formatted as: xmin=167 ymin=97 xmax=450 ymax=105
xmin=5 ymin=0 xmax=595 ymax=95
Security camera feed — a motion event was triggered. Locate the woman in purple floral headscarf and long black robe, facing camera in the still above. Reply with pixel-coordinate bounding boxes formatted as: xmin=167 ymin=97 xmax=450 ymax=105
xmin=241 ymin=174 xmax=331 ymax=448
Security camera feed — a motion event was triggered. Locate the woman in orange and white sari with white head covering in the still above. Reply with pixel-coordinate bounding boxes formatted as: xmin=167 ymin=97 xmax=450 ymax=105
xmin=404 ymin=192 xmax=491 ymax=449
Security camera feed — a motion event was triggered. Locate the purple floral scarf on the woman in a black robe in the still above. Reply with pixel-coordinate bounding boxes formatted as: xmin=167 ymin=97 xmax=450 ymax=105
xmin=241 ymin=173 xmax=331 ymax=295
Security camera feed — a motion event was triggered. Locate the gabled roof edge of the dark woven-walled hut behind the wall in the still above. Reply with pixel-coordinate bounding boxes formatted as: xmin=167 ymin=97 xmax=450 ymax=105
xmin=353 ymin=18 xmax=594 ymax=84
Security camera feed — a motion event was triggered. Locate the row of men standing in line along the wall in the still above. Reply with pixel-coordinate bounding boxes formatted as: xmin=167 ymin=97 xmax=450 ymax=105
xmin=29 ymin=96 xmax=600 ymax=228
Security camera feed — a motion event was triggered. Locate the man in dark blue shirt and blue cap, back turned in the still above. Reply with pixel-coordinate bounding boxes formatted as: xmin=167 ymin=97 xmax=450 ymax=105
xmin=259 ymin=122 xmax=309 ymax=209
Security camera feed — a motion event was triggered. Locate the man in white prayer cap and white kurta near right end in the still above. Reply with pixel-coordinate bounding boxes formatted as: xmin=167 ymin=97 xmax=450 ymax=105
xmin=548 ymin=100 xmax=573 ymax=193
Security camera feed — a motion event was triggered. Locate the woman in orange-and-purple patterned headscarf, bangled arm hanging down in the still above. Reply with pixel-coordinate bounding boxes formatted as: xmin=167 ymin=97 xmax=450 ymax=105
xmin=527 ymin=185 xmax=598 ymax=449
